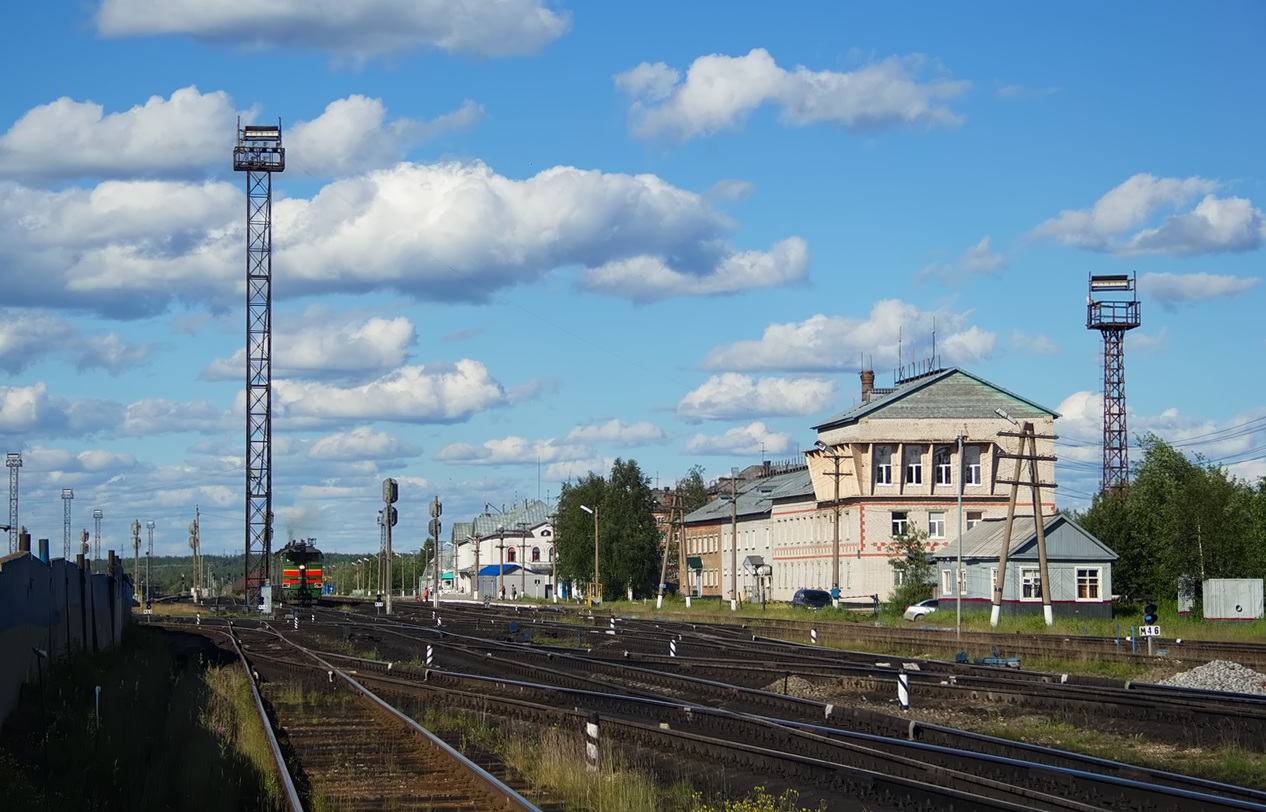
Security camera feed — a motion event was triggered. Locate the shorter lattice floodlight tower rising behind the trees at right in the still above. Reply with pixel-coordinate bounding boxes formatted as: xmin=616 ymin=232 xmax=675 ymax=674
xmin=1086 ymin=274 xmax=1141 ymax=495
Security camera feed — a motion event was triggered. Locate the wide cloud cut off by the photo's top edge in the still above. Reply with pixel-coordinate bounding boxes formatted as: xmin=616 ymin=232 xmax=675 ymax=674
xmin=96 ymin=0 xmax=570 ymax=58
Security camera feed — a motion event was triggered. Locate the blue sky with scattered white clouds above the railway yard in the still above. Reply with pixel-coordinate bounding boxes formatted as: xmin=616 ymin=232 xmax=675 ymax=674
xmin=0 ymin=0 xmax=1266 ymax=554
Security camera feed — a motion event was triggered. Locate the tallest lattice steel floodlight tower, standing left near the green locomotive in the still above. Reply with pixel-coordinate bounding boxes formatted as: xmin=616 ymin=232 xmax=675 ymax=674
xmin=233 ymin=119 xmax=286 ymax=607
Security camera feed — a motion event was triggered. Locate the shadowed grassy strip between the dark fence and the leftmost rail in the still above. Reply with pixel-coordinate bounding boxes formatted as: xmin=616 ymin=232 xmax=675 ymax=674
xmin=0 ymin=626 xmax=282 ymax=812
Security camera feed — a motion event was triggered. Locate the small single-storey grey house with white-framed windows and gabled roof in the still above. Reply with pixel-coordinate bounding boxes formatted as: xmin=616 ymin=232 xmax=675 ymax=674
xmin=932 ymin=516 xmax=1117 ymax=618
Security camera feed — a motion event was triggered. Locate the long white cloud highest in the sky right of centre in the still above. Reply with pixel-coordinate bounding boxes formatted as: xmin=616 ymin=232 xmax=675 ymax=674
xmin=615 ymin=48 xmax=967 ymax=141
